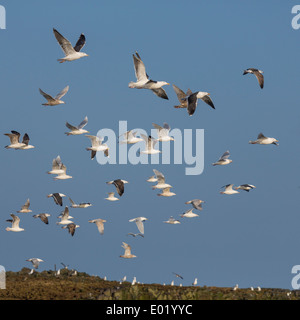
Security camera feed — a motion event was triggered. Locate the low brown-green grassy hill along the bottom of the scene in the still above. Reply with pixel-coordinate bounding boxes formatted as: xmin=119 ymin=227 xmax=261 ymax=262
xmin=0 ymin=268 xmax=300 ymax=300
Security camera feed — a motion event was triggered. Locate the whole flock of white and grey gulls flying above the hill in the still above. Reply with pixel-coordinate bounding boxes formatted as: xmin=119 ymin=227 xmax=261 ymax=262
xmin=5 ymin=29 xmax=278 ymax=284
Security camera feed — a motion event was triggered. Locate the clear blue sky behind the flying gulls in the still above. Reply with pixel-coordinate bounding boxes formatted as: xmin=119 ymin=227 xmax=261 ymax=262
xmin=0 ymin=0 xmax=300 ymax=288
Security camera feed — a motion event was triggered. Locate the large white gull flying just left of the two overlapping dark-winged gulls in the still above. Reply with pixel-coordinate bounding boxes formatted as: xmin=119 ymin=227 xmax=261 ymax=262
xmin=128 ymin=52 xmax=169 ymax=100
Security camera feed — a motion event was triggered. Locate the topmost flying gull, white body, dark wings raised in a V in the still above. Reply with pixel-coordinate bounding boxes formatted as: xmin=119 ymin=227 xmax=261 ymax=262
xmin=53 ymin=28 xmax=88 ymax=63
